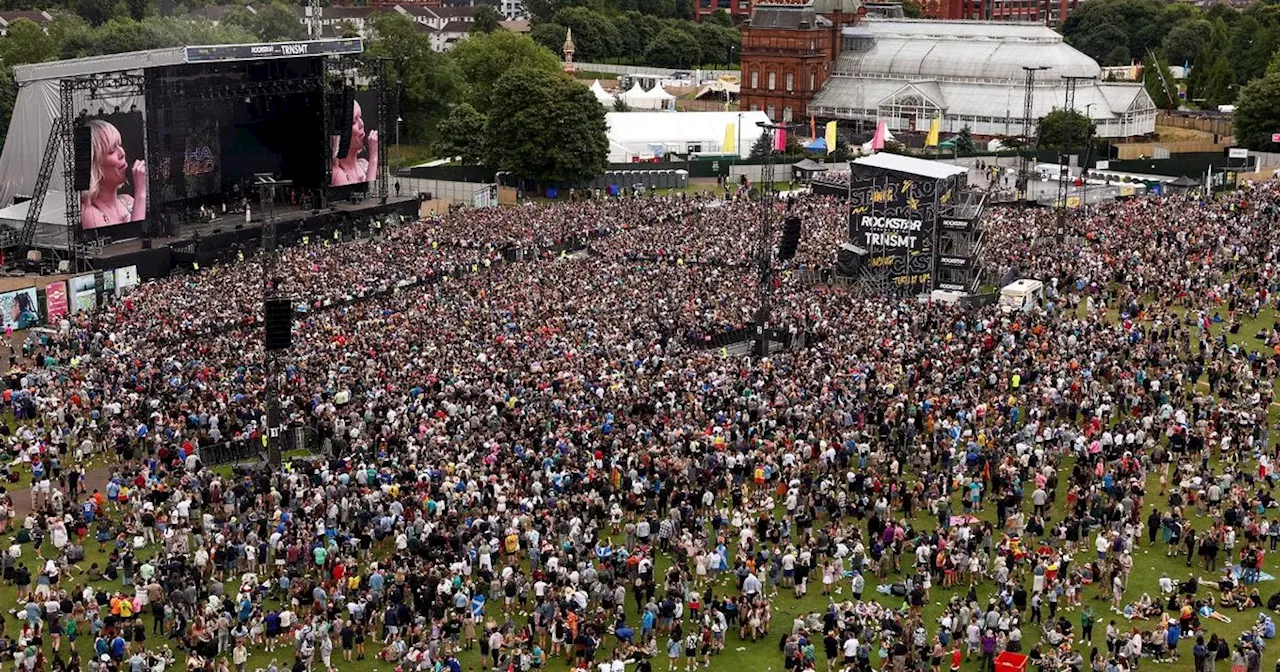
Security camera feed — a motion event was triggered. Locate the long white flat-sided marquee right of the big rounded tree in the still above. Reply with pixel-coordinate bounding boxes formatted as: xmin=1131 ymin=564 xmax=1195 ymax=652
xmin=604 ymin=111 xmax=769 ymax=163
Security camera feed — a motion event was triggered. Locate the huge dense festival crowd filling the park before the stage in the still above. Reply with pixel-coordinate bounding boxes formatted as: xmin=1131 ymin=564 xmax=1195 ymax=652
xmin=0 ymin=177 xmax=1280 ymax=672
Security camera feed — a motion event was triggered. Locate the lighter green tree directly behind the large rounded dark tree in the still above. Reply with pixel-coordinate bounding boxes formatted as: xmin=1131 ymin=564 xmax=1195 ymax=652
xmin=449 ymin=31 xmax=561 ymax=114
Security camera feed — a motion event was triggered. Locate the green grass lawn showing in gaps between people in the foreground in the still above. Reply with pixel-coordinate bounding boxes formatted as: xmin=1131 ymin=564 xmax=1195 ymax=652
xmin=0 ymin=305 xmax=1280 ymax=672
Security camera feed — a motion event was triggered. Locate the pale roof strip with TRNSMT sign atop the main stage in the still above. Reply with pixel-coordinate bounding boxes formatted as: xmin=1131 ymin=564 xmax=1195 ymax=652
xmin=13 ymin=37 xmax=365 ymax=84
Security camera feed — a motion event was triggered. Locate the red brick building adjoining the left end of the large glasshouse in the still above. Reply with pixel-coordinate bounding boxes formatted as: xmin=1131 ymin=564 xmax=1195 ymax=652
xmin=741 ymin=0 xmax=860 ymax=122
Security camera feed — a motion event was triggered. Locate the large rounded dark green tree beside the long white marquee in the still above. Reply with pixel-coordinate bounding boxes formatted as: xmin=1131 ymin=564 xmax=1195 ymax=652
xmin=485 ymin=68 xmax=609 ymax=184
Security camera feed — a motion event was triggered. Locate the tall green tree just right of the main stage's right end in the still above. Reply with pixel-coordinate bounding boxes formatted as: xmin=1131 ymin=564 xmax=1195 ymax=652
xmin=369 ymin=13 xmax=466 ymax=141
